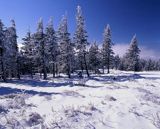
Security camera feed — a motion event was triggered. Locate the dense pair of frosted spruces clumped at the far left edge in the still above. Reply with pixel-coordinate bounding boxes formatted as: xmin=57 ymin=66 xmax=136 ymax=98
xmin=0 ymin=20 xmax=20 ymax=81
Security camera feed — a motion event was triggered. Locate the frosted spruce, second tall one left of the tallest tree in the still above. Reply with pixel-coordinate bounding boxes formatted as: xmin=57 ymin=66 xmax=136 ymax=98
xmin=45 ymin=18 xmax=59 ymax=77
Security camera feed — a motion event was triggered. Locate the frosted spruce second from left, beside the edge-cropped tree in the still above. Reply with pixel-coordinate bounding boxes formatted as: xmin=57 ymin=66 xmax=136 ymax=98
xmin=5 ymin=20 xmax=20 ymax=79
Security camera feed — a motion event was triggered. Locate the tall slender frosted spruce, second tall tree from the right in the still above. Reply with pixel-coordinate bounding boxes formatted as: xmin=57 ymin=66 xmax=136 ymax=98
xmin=102 ymin=25 xmax=114 ymax=73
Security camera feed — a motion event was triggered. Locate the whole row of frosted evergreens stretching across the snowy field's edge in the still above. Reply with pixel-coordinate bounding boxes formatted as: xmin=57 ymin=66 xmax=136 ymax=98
xmin=0 ymin=6 xmax=160 ymax=81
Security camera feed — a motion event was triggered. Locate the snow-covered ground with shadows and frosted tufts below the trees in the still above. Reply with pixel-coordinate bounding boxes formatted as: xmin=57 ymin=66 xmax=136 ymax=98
xmin=0 ymin=71 xmax=160 ymax=129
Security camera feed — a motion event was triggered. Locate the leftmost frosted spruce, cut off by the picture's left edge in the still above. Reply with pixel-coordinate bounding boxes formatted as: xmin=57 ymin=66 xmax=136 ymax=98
xmin=0 ymin=20 xmax=6 ymax=81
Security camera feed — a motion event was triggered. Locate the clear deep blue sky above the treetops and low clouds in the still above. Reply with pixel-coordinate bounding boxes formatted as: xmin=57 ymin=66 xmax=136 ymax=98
xmin=0 ymin=0 xmax=160 ymax=51
